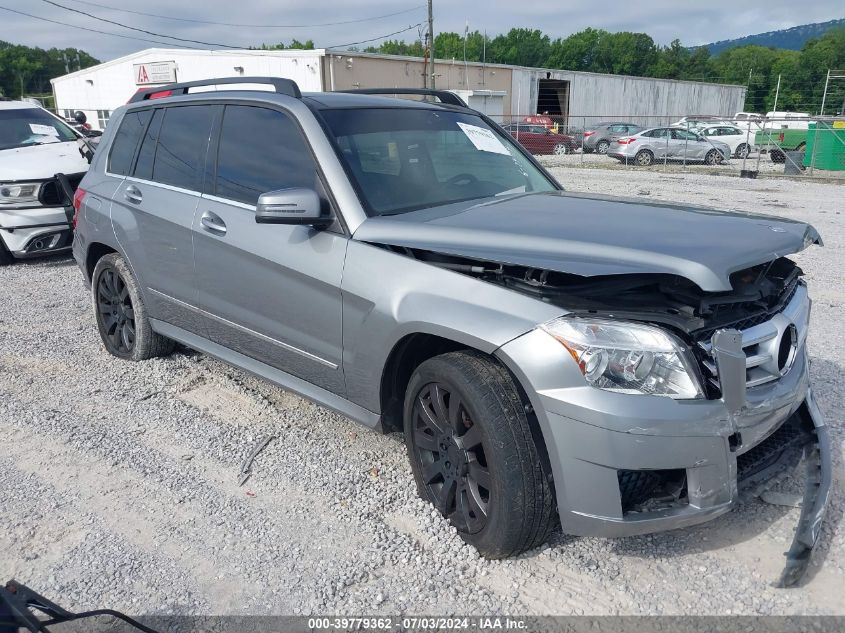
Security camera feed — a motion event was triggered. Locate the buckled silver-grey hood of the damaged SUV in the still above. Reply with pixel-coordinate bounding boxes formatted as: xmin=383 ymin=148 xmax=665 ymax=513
xmin=354 ymin=192 xmax=821 ymax=292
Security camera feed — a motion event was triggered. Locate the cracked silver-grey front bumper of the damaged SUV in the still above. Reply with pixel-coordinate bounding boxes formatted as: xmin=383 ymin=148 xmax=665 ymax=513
xmin=497 ymin=330 xmax=830 ymax=537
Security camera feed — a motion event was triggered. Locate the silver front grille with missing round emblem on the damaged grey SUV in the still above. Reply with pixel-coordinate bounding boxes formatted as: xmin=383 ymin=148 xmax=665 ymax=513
xmin=699 ymin=284 xmax=810 ymax=389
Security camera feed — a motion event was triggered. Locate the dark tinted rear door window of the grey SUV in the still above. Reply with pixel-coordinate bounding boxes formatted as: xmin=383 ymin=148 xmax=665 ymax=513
xmin=152 ymin=106 xmax=214 ymax=191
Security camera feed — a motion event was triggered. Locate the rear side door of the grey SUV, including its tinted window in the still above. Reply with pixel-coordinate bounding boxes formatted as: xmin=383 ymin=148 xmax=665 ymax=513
xmin=112 ymin=105 xmax=215 ymax=331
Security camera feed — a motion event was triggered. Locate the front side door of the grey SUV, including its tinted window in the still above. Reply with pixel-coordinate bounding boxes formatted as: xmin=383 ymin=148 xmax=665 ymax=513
xmin=193 ymin=104 xmax=347 ymax=394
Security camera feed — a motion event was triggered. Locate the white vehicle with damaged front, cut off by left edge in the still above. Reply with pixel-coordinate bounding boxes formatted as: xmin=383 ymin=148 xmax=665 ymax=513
xmin=0 ymin=101 xmax=88 ymax=265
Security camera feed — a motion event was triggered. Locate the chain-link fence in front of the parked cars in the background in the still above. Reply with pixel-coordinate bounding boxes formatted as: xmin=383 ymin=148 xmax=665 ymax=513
xmin=491 ymin=113 xmax=845 ymax=180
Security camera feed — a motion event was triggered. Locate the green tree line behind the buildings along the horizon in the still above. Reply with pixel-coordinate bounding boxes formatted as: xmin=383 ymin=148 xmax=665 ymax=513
xmin=6 ymin=28 xmax=845 ymax=114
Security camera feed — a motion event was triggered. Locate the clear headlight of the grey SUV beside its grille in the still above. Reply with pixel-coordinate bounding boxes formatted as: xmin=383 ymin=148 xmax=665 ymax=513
xmin=541 ymin=317 xmax=704 ymax=399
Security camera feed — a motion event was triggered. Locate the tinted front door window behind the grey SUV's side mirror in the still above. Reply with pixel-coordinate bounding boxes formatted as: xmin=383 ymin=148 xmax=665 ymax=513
xmin=213 ymin=105 xmax=317 ymax=204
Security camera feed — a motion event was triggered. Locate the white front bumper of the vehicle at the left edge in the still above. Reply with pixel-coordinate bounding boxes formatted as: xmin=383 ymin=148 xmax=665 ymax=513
xmin=0 ymin=207 xmax=72 ymax=258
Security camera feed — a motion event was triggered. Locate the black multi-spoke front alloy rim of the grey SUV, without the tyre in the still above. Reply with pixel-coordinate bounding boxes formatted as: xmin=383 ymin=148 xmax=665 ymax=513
xmin=412 ymin=383 xmax=492 ymax=534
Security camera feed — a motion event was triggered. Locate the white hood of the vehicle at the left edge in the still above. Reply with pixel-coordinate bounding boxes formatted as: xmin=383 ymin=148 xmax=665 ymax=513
xmin=0 ymin=141 xmax=88 ymax=182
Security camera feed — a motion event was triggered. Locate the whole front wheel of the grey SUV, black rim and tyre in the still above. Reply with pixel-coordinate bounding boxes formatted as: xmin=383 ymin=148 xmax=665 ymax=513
xmin=404 ymin=351 xmax=557 ymax=559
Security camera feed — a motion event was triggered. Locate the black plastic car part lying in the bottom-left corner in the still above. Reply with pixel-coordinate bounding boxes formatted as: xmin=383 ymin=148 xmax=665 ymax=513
xmin=0 ymin=580 xmax=159 ymax=633
